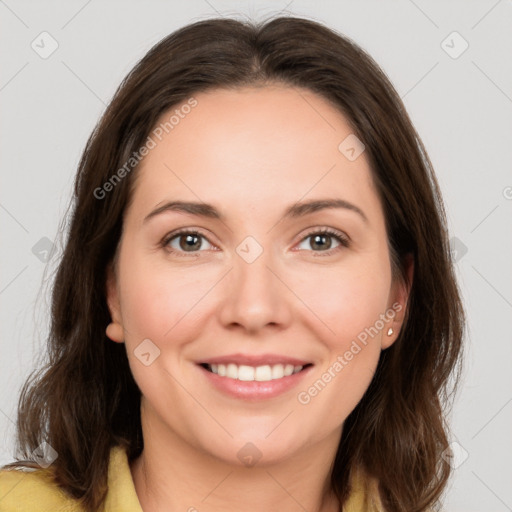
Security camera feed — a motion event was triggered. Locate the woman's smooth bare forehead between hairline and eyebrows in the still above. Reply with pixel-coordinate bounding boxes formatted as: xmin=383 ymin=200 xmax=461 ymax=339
xmin=134 ymin=86 xmax=378 ymax=224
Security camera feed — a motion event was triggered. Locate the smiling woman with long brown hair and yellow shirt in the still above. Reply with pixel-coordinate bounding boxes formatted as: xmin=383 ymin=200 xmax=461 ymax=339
xmin=0 ymin=17 xmax=464 ymax=512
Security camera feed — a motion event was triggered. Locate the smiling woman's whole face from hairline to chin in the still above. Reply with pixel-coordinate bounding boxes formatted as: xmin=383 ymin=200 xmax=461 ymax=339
xmin=104 ymin=86 xmax=406 ymax=464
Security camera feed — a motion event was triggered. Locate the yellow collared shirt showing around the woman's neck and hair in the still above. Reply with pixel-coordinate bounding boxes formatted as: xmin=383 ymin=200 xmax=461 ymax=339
xmin=0 ymin=446 xmax=382 ymax=512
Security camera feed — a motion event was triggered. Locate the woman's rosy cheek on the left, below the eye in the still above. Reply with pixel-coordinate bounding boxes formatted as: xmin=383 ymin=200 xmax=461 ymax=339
xmin=115 ymin=252 xmax=211 ymax=396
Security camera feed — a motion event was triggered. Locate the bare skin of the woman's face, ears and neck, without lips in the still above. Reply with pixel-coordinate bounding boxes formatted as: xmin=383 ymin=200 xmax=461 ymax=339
xmin=107 ymin=86 xmax=412 ymax=512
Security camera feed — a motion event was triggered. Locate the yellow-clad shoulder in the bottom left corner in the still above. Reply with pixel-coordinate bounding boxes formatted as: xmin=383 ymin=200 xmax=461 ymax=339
xmin=0 ymin=469 xmax=82 ymax=512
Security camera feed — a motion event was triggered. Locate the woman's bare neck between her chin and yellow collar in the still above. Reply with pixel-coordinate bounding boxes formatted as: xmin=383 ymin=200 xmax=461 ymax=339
xmin=130 ymin=404 xmax=341 ymax=512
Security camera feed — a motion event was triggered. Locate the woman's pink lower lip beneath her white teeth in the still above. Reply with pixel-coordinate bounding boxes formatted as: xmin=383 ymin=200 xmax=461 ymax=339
xmin=197 ymin=365 xmax=313 ymax=400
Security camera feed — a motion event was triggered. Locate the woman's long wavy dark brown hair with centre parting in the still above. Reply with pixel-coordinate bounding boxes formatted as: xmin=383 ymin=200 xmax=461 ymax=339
xmin=2 ymin=17 xmax=464 ymax=512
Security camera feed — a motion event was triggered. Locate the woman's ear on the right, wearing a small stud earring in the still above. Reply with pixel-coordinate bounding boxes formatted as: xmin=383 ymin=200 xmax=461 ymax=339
xmin=381 ymin=253 xmax=414 ymax=350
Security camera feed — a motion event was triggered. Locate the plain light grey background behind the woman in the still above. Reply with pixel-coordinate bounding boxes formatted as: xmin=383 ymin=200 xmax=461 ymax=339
xmin=0 ymin=0 xmax=512 ymax=512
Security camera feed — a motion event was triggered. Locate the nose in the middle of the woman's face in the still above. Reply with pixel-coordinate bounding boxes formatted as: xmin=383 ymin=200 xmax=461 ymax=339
xmin=218 ymin=245 xmax=293 ymax=334
